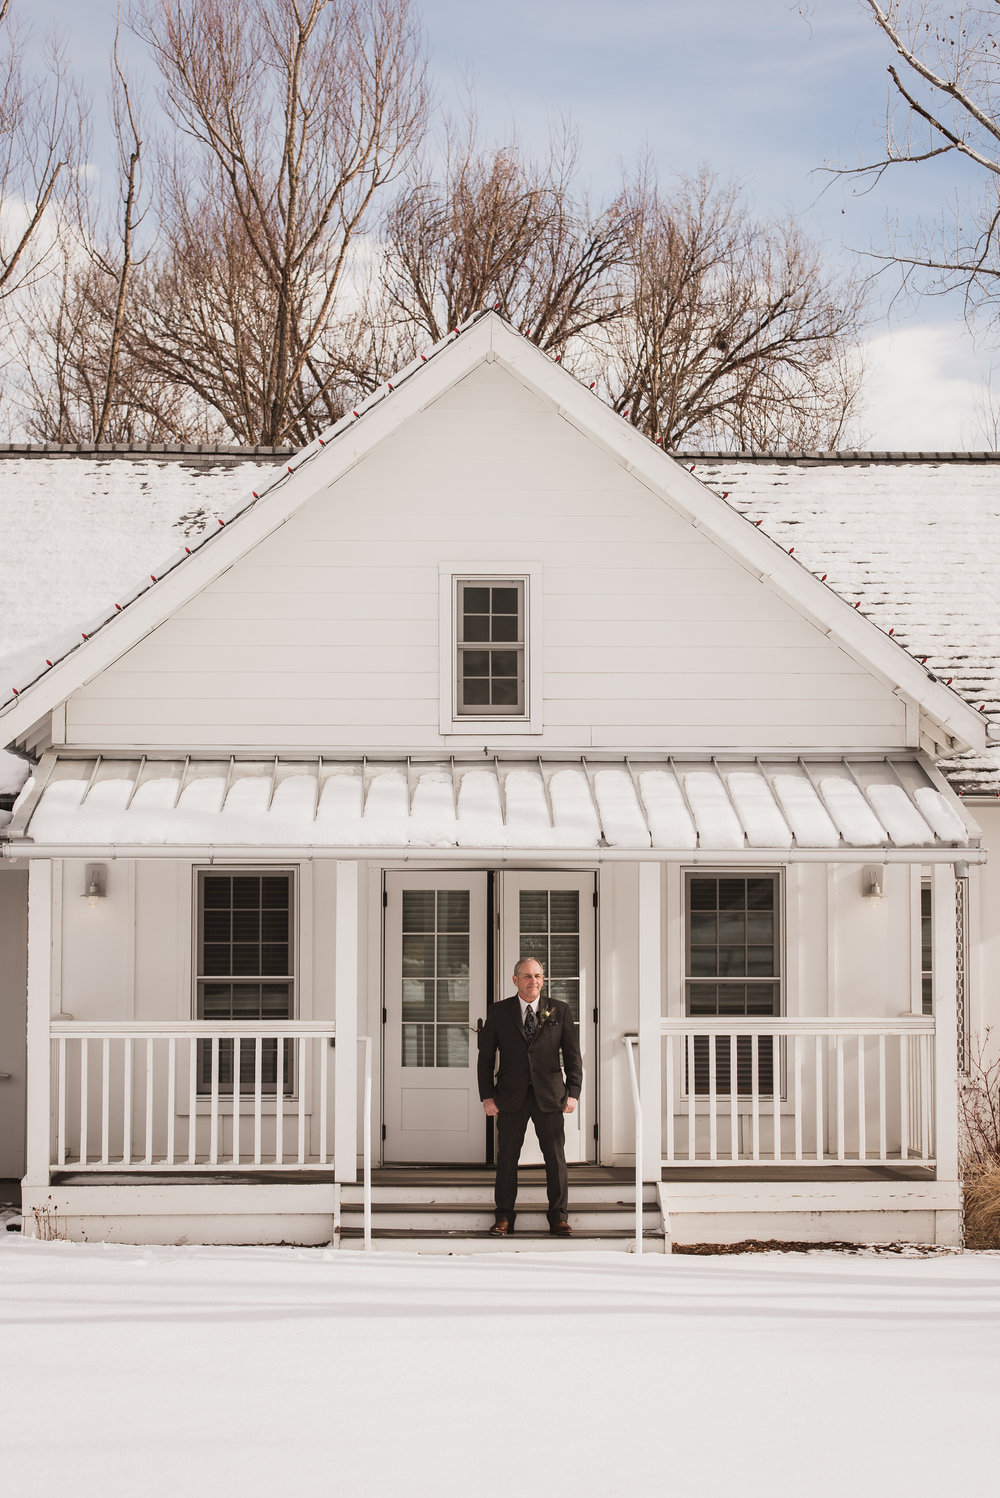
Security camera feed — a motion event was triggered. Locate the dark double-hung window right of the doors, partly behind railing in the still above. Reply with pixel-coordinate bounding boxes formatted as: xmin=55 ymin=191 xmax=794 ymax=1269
xmin=684 ymin=873 xmax=781 ymax=1097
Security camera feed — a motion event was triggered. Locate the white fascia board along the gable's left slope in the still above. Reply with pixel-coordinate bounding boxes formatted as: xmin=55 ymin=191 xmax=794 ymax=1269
xmin=0 ymin=318 xmax=499 ymax=745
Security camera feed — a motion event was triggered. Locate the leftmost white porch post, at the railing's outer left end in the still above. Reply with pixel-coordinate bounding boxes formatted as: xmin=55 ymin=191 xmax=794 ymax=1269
xmin=24 ymin=858 xmax=52 ymax=1186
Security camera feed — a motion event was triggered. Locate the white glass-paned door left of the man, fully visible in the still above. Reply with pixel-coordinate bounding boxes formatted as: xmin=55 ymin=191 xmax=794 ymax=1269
xmin=383 ymin=872 xmax=487 ymax=1164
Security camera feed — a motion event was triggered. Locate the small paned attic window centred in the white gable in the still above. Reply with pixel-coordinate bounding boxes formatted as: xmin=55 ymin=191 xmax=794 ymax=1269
xmin=455 ymin=577 xmax=525 ymax=718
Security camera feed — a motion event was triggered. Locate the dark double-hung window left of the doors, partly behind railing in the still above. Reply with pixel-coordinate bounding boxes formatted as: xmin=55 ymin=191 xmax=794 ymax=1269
xmin=196 ymin=869 xmax=295 ymax=1095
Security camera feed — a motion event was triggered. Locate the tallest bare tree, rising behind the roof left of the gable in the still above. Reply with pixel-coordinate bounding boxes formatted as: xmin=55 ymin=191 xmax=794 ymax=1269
xmin=127 ymin=0 xmax=427 ymax=443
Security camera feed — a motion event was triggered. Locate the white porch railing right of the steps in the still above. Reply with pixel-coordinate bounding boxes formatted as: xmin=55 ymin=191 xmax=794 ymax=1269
xmin=660 ymin=1016 xmax=936 ymax=1167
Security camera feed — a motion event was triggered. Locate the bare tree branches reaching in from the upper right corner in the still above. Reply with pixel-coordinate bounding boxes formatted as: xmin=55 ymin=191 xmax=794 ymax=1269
xmin=841 ymin=0 xmax=1000 ymax=321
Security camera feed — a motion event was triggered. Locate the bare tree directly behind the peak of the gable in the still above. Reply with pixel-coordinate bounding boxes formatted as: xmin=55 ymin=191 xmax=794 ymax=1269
xmin=363 ymin=115 xmax=626 ymax=377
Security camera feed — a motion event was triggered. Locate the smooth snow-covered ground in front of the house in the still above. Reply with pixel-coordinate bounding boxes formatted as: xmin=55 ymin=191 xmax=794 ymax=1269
xmin=0 ymin=1239 xmax=1000 ymax=1498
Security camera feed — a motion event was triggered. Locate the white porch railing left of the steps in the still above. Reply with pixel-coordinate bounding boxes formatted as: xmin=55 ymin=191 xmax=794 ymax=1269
xmin=51 ymin=1020 xmax=335 ymax=1171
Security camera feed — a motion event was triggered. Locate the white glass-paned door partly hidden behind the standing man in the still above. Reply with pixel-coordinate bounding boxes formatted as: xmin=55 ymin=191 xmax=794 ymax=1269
xmin=497 ymin=872 xmax=597 ymax=1165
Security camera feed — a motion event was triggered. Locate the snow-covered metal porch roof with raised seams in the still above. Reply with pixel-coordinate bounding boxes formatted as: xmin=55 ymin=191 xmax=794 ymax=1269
xmin=9 ymin=753 xmax=979 ymax=857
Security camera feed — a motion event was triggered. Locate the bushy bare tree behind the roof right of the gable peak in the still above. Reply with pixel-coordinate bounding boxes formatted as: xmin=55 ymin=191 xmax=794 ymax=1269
xmin=605 ymin=169 xmax=862 ymax=451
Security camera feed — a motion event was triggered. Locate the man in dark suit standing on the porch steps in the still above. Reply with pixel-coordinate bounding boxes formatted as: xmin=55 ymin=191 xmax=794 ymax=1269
xmin=479 ymin=957 xmax=584 ymax=1237
